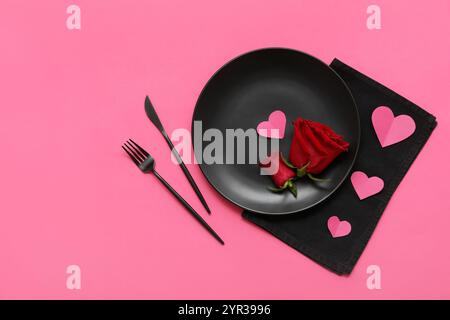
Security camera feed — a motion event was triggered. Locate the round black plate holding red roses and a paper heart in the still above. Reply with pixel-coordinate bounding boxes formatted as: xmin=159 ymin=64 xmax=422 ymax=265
xmin=192 ymin=48 xmax=360 ymax=214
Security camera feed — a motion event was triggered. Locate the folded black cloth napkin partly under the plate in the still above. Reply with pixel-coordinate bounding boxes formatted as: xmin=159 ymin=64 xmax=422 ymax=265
xmin=243 ymin=59 xmax=437 ymax=274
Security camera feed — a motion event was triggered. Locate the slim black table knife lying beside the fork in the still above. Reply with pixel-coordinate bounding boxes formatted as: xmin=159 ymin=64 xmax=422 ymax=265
xmin=145 ymin=96 xmax=211 ymax=214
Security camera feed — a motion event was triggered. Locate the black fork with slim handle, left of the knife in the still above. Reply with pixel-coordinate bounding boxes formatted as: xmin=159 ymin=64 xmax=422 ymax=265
xmin=122 ymin=139 xmax=225 ymax=244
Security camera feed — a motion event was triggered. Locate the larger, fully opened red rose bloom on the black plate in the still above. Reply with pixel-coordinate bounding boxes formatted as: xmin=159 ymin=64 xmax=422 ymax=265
xmin=289 ymin=118 xmax=349 ymax=174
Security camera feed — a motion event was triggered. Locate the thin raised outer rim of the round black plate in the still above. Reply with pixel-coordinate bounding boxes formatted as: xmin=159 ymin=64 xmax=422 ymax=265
xmin=191 ymin=47 xmax=361 ymax=216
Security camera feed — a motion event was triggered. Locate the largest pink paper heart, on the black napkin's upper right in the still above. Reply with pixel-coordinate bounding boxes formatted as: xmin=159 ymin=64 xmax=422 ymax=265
xmin=372 ymin=106 xmax=416 ymax=148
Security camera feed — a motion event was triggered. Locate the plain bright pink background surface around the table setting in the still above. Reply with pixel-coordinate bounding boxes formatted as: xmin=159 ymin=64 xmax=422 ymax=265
xmin=0 ymin=0 xmax=450 ymax=299
